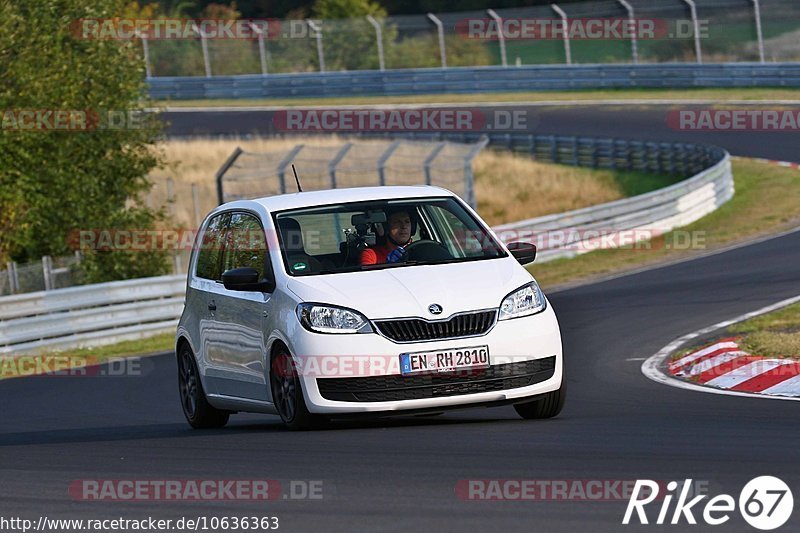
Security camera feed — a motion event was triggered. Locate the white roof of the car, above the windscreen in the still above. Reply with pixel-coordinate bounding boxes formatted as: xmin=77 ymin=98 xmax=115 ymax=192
xmin=220 ymin=185 xmax=455 ymax=212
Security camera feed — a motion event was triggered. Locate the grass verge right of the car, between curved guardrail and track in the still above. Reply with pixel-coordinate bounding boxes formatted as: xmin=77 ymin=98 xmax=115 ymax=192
xmin=528 ymin=159 xmax=800 ymax=287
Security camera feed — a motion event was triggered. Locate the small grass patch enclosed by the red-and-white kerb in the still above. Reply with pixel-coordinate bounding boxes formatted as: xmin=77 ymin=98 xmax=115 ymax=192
xmin=728 ymin=304 xmax=800 ymax=357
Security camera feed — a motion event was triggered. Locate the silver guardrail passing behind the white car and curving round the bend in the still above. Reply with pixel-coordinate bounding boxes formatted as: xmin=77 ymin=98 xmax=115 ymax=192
xmin=0 ymin=135 xmax=734 ymax=357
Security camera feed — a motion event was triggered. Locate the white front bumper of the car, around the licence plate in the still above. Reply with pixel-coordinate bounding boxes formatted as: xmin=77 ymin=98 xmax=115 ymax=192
xmin=282 ymin=305 xmax=563 ymax=414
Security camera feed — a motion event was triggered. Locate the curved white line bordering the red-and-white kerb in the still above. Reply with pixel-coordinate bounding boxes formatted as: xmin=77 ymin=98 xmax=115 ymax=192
xmin=642 ymin=296 xmax=800 ymax=401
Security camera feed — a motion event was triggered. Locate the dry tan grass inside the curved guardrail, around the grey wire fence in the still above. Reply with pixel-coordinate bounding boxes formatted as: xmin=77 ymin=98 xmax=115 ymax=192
xmin=150 ymin=136 xmax=674 ymax=227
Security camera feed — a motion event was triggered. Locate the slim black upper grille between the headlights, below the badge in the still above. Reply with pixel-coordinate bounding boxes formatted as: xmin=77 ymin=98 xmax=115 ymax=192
xmin=375 ymin=310 xmax=497 ymax=342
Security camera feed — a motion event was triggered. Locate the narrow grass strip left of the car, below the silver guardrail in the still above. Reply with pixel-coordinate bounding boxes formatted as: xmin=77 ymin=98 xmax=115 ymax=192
xmin=0 ymin=333 xmax=175 ymax=380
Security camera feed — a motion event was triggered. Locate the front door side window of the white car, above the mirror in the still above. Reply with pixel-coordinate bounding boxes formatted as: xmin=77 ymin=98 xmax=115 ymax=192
xmin=222 ymin=213 xmax=267 ymax=279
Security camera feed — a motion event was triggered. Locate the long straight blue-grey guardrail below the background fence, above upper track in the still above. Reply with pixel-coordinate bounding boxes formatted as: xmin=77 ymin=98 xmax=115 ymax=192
xmin=147 ymin=63 xmax=800 ymax=100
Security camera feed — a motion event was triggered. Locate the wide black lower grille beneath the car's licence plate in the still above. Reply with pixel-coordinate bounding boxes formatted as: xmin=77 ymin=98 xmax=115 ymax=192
xmin=317 ymin=356 xmax=556 ymax=402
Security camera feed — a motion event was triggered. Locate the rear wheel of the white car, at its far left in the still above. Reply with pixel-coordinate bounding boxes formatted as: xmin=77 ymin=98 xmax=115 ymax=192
xmin=178 ymin=343 xmax=230 ymax=429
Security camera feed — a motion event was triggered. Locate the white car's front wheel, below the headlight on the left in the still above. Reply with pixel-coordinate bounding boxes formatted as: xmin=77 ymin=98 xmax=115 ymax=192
xmin=269 ymin=346 xmax=328 ymax=431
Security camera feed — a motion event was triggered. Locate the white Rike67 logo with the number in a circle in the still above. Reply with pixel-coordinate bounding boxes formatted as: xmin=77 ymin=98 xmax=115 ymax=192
xmin=622 ymin=476 xmax=794 ymax=531
